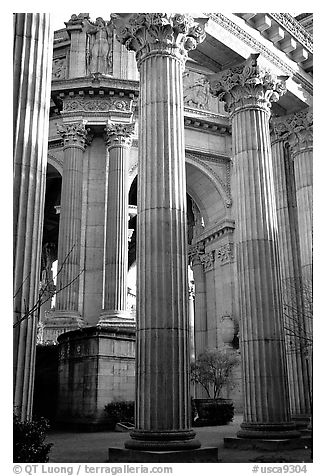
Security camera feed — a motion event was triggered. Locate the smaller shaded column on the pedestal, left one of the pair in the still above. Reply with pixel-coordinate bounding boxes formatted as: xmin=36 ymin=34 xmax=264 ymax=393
xmin=55 ymin=122 xmax=89 ymax=329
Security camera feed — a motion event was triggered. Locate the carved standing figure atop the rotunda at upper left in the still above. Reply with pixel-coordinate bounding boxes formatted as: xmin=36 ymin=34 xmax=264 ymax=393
xmin=87 ymin=17 xmax=113 ymax=74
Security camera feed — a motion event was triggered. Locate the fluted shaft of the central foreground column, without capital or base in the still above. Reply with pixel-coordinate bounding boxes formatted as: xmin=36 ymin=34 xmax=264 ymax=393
xmin=136 ymin=51 xmax=190 ymax=432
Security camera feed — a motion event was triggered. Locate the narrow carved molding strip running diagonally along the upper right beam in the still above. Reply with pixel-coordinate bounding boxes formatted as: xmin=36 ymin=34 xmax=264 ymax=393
xmin=205 ymin=13 xmax=313 ymax=95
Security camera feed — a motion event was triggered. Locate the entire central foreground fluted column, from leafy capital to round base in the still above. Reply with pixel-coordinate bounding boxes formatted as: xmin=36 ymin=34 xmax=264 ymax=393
xmin=117 ymin=13 xmax=205 ymax=450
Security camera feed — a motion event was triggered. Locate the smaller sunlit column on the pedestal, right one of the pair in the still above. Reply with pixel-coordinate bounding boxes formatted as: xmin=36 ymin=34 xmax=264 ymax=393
xmin=99 ymin=122 xmax=135 ymax=326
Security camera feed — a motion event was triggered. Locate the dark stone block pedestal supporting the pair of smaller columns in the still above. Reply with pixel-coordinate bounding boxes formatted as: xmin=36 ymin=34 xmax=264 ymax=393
xmin=56 ymin=326 xmax=135 ymax=431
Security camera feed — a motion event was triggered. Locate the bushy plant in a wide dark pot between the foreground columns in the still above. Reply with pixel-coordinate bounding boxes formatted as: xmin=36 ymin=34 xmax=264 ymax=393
xmin=191 ymin=349 xmax=238 ymax=426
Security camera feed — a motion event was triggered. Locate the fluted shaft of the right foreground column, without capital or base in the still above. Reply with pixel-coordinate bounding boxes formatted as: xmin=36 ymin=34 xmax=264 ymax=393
xmin=232 ymin=110 xmax=289 ymax=425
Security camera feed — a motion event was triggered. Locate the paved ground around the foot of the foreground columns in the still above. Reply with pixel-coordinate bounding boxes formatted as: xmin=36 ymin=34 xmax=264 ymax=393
xmin=47 ymin=415 xmax=311 ymax=463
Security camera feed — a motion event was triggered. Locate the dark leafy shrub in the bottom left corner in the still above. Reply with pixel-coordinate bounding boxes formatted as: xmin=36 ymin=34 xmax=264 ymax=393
xmin=13 ymin=415 xmax=52 ymax=463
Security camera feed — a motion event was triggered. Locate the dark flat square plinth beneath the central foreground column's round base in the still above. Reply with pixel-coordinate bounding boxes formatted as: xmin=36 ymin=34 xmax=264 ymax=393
xmin=108 ymin=447 xmax=219 ymax=463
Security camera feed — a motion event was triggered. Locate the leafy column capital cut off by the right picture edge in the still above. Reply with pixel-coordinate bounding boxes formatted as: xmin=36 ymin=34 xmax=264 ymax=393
xmin=271 ymin=107 xmax=313 ymax=155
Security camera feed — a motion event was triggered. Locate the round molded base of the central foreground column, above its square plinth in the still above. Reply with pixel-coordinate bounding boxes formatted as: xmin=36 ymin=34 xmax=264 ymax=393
xmin=125 ymin=430 xmax=201 ymax=451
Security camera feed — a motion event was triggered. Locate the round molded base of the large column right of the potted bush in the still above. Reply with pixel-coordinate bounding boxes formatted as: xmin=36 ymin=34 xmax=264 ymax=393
xmin=237 ymin=422 xmax=301 ymax=440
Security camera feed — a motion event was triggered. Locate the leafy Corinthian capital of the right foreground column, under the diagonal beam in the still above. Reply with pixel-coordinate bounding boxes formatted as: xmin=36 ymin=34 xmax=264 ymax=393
xmin=209 ymin=53 xmax=287 ymax=113
